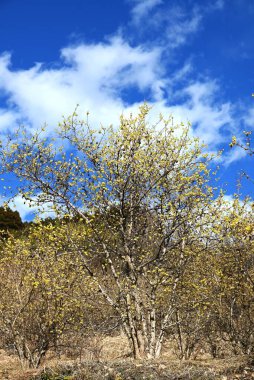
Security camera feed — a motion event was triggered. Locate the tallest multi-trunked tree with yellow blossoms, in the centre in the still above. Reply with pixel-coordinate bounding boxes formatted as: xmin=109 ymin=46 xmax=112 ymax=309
xmin=1 ymin=105 xmax=218 ymax=359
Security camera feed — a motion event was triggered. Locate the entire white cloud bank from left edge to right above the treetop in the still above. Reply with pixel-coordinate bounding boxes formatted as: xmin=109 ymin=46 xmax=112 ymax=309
xmin=0 ymin=37 xmax=236 ymax=162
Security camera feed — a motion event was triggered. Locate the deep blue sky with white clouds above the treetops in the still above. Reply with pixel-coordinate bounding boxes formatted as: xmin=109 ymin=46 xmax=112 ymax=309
xmin=0 ymin=0 xmax=254 ymax=218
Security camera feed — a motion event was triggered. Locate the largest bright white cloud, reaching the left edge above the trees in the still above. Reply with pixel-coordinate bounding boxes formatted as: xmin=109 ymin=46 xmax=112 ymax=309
xmin=0 ymin=37 xmax=163 ymax=132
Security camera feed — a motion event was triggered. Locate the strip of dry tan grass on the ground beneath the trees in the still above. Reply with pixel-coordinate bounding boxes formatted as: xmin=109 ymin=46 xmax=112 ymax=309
xmin=0 ymin=336 xmax=254 ymax=380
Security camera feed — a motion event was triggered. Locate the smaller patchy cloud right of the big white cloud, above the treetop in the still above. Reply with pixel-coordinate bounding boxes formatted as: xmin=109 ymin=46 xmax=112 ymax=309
xmin=136 ymin=80 xmax=233 ymax=148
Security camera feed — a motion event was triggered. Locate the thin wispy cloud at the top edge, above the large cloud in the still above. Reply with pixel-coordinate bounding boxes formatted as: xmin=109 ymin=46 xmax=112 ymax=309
xmin=129 ymin=0 xmax=224 ymax=51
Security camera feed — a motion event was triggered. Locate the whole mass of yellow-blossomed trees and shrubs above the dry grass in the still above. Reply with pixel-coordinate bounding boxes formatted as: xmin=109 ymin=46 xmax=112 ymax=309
xmin=0 ymin=105 xmax=254 ymax=366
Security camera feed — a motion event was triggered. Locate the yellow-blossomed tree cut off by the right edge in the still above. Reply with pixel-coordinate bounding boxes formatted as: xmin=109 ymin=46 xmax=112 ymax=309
xmin=213 ymin=197 xmax=254 ymax=356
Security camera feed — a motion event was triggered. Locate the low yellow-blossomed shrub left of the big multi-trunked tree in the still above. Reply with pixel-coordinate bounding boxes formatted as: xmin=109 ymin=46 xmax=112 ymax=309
xmin=0 ymin=224 xmax=92 ymax=367
